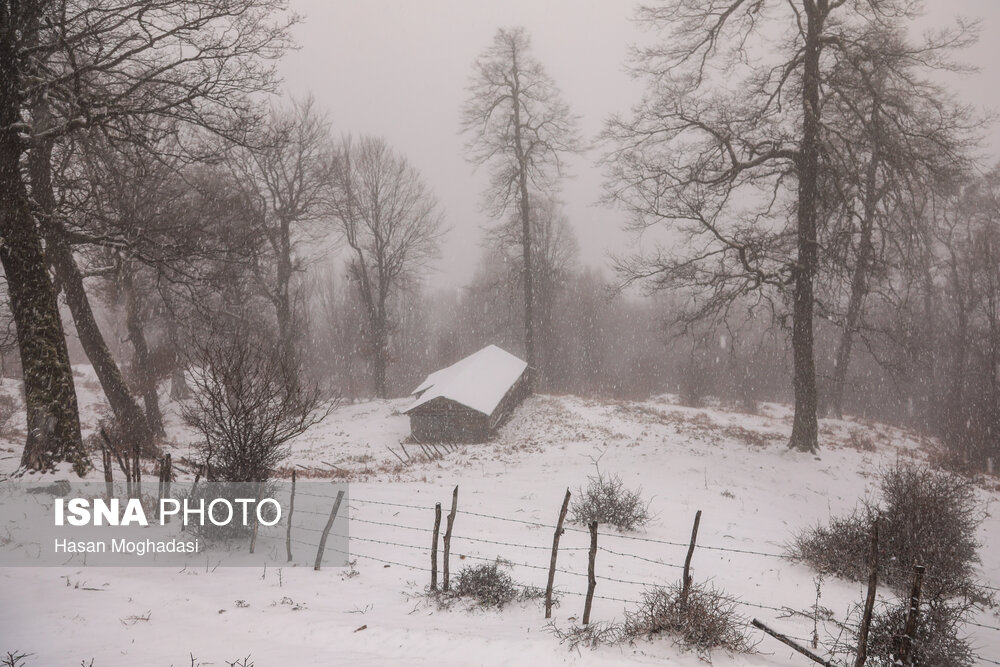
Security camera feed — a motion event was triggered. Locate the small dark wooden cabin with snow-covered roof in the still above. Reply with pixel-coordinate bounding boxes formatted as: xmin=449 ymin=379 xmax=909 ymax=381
xmin=403 ymin=345 xmax=530 ymax=442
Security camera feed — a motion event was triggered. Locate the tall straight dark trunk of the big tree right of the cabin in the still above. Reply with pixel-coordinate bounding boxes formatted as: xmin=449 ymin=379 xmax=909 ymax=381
xmin=788 ymin=0 xmax=826 ymax=452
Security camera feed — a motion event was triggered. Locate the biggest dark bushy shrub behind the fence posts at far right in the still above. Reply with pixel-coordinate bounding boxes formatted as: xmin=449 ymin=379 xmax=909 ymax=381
xmin=792 ymin=462 xmax=989 ymax=601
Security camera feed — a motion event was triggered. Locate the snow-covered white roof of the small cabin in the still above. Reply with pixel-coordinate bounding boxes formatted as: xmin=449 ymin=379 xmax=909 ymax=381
xmin=403 ymin=345 xmax=528 ymax=415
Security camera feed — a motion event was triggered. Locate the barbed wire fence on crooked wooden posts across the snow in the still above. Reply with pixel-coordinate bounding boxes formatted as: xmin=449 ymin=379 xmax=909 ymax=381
xmin=276 ymin=487 xmax=1000 ymax=665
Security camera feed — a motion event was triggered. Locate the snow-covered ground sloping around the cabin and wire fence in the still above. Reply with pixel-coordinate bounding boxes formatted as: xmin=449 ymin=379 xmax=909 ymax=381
xmin=0 ymin=368 xmax=1000 ymax=667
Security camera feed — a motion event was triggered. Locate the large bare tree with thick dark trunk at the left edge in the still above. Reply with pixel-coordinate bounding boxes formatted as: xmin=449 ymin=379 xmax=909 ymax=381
xmin=0 ymin=0 xmax=288 ymax=468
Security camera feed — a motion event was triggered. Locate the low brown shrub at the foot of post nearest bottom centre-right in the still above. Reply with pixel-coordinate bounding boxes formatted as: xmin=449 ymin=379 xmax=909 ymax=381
xmin=625 ymin=582 xmax=755 ymax=659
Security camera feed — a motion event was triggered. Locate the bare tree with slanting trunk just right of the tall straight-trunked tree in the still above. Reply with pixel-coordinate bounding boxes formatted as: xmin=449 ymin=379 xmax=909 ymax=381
xmin=822 ymin=25 xmax=979 ymax=417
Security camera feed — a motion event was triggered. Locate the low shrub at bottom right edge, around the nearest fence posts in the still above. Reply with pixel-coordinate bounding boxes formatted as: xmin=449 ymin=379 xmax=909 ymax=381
xmin=832 ymin=597 xmax=975 ymax=667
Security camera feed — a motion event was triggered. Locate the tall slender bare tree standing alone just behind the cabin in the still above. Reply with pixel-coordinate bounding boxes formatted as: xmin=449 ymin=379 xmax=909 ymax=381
xmin=462 ymin=27 xmax=580 ymax=380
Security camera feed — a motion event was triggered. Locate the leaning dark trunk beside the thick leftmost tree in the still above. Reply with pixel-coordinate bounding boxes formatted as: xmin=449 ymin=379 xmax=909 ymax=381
xmin=28 ymin=104 xmax=152 ymax=450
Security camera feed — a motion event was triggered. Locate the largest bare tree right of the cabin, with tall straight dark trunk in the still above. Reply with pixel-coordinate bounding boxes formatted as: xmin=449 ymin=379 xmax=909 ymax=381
xmin=606 ymin=0 xmax=968 ymax=452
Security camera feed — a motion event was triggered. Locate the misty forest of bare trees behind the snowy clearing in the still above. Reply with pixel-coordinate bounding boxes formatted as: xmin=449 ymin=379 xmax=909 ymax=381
xmin=0 ymin=0 xmax=1000 ymax=478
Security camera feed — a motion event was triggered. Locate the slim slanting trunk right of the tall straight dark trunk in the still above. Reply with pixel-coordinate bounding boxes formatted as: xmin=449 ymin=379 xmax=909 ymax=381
xmin=830 ymin=107 xmax=880 ymax=419
